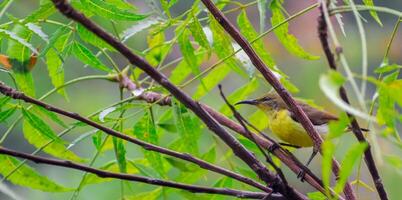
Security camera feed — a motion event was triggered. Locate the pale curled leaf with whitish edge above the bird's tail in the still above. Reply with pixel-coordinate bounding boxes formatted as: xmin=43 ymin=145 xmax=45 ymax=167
xmin=319 ymin=70 xmax=374 ymax=120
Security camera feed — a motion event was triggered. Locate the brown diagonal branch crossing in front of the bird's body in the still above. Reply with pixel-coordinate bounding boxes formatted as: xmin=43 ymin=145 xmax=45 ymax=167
xmin=202 ymin=0 xmax=356 ymax=200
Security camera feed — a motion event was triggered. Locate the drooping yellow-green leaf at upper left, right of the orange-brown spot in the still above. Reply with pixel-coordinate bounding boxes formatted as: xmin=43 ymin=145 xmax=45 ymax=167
xmin=45 ymin=32 xmax=71 ymax=99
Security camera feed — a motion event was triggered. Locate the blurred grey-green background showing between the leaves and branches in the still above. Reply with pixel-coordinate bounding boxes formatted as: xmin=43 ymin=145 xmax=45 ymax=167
xmin=0 ymin=0 xmax=402 ymax=200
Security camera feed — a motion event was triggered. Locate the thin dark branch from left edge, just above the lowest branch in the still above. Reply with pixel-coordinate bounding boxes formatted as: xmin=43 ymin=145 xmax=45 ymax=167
xmin=0 ymin=81 xmax=272 ymax=193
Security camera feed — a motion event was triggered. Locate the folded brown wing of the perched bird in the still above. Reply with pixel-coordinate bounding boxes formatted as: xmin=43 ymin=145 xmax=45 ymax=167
xmin=290 ymin=102 xmax=338 ymax=125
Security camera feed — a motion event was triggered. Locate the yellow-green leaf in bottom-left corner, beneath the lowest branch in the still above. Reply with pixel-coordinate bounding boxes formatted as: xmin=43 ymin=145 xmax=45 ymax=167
xmin=0 ymin=155 xmax=72 ymax=192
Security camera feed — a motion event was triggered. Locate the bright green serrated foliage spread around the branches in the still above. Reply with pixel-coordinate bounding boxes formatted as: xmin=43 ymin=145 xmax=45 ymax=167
xmin=0 ymin=0 xmax=402 ymax=199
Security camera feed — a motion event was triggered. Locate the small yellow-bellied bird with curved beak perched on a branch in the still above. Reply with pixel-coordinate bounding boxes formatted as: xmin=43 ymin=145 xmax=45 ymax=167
xmin=236 ymin=92 xmax=338 ymax=147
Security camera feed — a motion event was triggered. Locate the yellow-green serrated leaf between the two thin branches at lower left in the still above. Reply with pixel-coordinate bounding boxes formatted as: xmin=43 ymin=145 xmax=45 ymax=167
xmin=23 ymin=120 xmax=84 ymax=162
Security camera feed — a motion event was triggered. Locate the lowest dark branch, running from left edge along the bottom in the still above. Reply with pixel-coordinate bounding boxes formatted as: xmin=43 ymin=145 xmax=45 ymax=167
xmin=0 ymin=147 xmax=284 ymax=199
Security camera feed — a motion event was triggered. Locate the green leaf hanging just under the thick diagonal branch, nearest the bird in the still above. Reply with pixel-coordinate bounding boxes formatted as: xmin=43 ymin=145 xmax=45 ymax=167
xmin=172 ymin=99 xmax=201 ymax=155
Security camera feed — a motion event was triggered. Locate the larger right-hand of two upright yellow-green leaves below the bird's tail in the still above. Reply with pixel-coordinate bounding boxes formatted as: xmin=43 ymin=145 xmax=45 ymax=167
xmin=334 ymin=143 xmax=367 ymax=194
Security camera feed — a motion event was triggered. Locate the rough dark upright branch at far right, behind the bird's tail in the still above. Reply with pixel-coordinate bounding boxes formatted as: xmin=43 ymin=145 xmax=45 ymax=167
xmin=318 ymin=5 xmax=388 ymax=200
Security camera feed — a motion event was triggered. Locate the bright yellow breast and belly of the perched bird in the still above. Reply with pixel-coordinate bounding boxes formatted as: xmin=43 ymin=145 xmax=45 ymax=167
xmin=268 ymin=110 xmax=313 ymax=147
